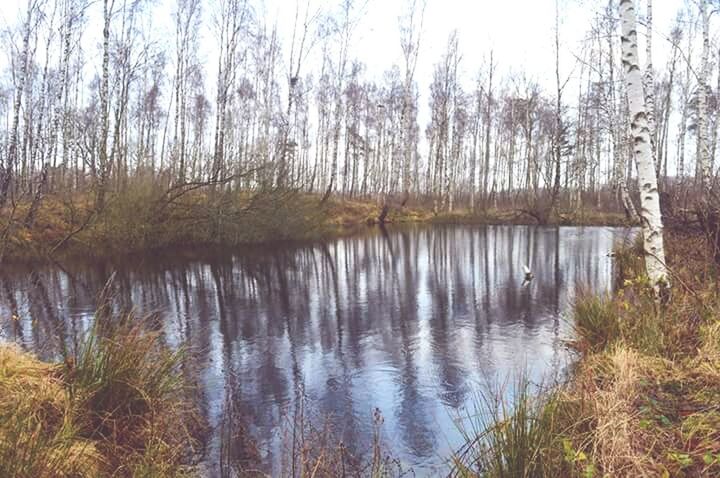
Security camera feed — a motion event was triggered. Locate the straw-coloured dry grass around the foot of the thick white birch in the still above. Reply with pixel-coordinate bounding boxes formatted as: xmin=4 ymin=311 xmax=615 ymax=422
xmin=565 ymin=231 xmax=720 ymax=477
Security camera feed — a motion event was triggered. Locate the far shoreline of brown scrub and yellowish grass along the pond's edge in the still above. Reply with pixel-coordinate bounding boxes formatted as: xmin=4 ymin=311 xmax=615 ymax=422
xmin=0 ymin=192 xmax=636 ymax=265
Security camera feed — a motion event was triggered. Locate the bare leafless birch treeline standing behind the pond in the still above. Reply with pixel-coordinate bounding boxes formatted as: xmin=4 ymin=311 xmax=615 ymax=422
xmin=0 ymin=0 xmax=720 ymax=223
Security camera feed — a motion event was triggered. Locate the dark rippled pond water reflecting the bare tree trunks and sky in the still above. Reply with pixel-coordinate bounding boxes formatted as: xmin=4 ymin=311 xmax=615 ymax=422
xmin=0 ymin=226 xmax=631 ymax=475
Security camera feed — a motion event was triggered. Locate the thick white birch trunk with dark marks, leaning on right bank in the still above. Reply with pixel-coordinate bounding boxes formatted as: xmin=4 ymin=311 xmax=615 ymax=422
xmin=619 ymin=0 xmax=669 ymax=292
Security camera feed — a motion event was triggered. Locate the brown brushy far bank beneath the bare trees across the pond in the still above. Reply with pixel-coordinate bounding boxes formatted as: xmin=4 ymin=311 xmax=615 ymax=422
xmin=0 ymin=184 xmax=629 ymax=261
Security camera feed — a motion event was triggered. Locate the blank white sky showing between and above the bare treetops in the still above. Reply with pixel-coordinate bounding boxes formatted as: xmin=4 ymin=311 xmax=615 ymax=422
xmin=0 ymin=0 xmax=683 ymax=96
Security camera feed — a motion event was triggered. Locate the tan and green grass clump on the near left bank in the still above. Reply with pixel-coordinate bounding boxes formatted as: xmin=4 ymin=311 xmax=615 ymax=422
xmin=0 ymin=316 xmax=196 ymax=478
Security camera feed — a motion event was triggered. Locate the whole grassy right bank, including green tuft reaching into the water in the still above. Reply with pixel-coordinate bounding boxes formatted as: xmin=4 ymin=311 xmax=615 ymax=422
xmin=454 ymin=234 xmax=720 ymax=477
